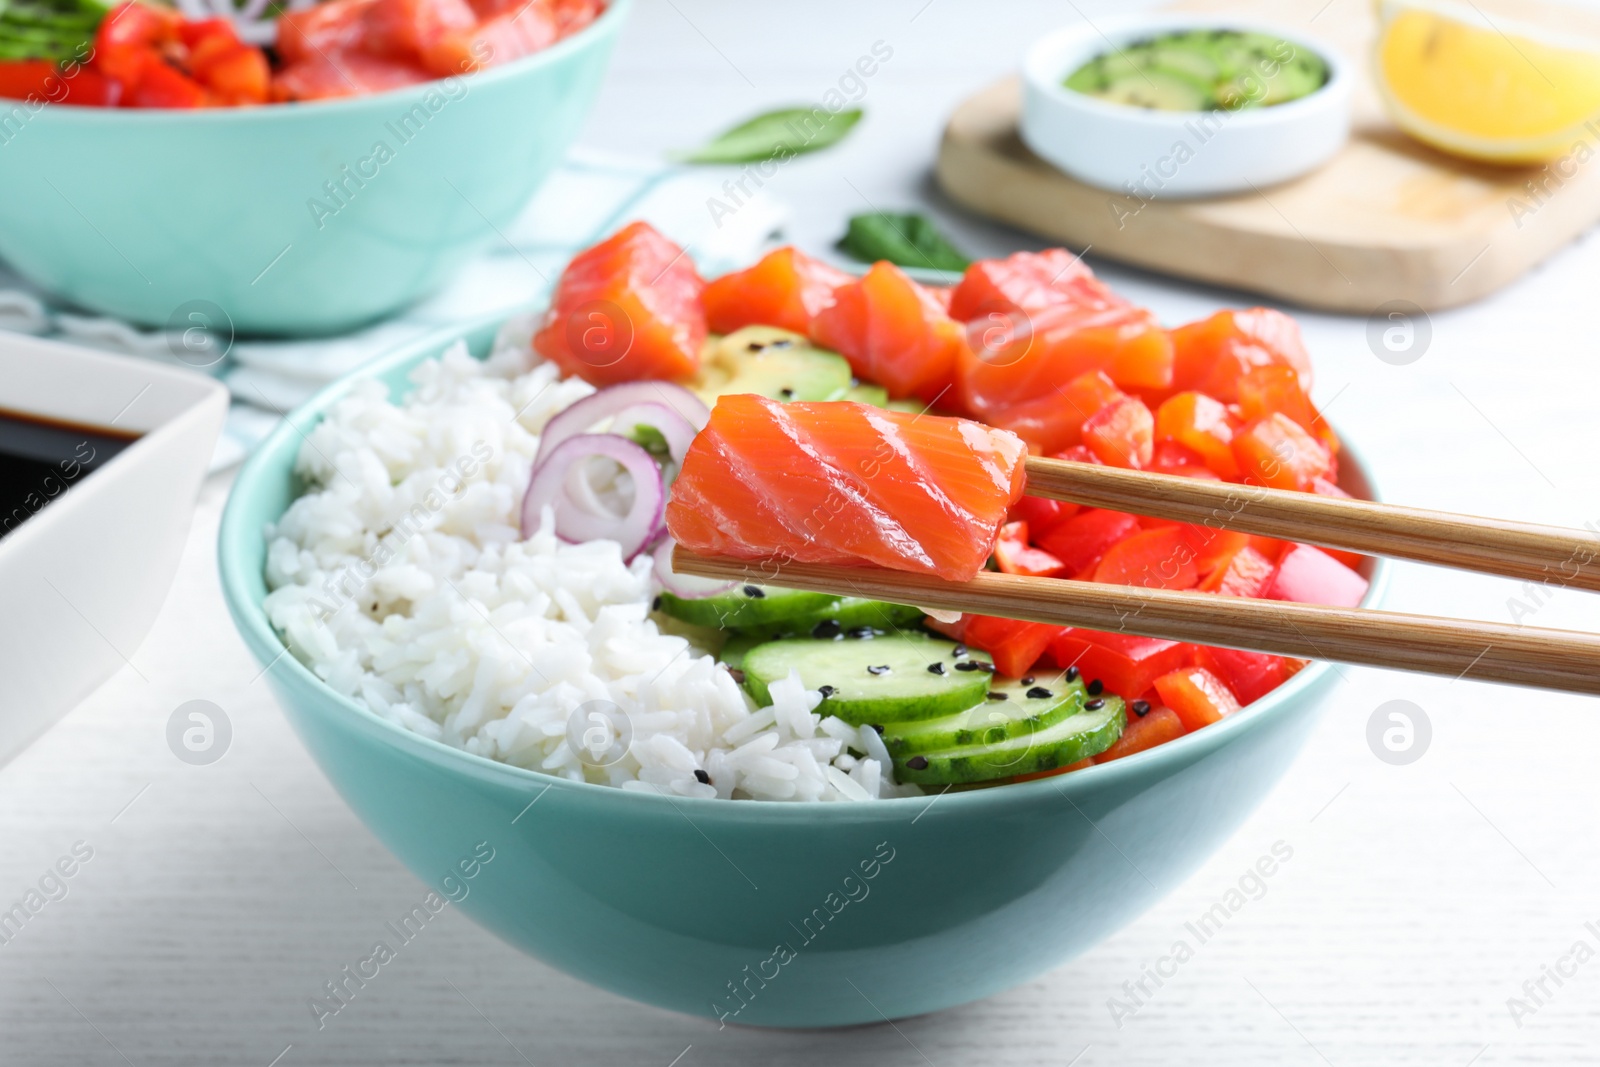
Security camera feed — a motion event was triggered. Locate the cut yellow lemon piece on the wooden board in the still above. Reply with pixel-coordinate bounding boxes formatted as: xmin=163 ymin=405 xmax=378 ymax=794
xmin=1373 ymin=0 xmax=1600 ymax=163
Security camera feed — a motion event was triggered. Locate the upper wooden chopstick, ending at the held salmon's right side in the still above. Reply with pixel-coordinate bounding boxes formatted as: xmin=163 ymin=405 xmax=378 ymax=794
xmin=1027 ymin=456 xmax=1600 ymax=590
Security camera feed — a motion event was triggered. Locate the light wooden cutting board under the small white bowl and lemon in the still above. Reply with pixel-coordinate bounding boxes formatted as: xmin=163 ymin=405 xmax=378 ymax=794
xmin=936 ymin=0 xmax=1600 ymax=314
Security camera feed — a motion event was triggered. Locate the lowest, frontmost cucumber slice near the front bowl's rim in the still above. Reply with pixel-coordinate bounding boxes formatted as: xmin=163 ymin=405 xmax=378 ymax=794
xmin=885 ymin=696 xmax=1125 ymax=785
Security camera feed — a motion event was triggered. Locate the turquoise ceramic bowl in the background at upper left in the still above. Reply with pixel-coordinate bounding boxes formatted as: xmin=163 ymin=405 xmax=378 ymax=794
xmin=0 ymin=0 xmax=629 ymax=334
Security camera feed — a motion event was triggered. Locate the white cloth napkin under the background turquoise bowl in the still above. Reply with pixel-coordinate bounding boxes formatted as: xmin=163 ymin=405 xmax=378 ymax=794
xmin=0 ymin=149 xmax=787 ymax=470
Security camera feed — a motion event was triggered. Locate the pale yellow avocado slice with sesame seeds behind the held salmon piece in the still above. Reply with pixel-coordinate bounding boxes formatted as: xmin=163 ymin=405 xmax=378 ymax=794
xmin=688 ymin=326 xmax=854 ymax=405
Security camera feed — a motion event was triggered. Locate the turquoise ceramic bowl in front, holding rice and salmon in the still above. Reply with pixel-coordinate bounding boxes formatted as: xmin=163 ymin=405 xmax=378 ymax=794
xmin=219 ymin=316 xmax=1386 ymax=1027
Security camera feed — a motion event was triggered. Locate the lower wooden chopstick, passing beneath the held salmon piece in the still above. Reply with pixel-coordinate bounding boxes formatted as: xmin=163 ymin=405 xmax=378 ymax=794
xmin=672 ymin=547 xmax=1600 ymax=694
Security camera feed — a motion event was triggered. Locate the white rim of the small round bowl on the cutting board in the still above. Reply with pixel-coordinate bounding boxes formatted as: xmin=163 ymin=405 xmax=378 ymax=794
xmin=1022 ymin=11 xmax=1350 ymax=131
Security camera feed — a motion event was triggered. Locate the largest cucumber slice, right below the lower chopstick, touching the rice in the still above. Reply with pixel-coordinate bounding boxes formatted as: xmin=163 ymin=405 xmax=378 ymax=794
xmin=744 ymin=633 xmax=994 ymax=725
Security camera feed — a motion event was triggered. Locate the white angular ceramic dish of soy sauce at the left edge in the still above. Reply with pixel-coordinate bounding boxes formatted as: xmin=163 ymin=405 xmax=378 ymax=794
xmin=0 ymin=333 xmax=227 ymax=765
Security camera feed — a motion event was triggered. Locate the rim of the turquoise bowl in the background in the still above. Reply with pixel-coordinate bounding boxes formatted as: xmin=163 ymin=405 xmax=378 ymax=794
xmin=20 ymin=0 xmax=634 ymax=126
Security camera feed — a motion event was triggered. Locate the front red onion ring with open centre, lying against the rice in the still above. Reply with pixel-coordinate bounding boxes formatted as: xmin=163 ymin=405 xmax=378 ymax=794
xmin=522 ymin=434 xmax=667 ymax=561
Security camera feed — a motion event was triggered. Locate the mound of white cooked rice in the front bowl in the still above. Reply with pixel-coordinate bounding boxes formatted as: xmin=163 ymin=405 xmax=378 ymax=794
xmin=266 ymin=323 xmax=920 ymax=800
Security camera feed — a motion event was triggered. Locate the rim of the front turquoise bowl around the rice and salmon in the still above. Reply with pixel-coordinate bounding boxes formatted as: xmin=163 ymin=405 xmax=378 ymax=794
xmin=216 ymin=295 xmax=1390 ymax=812
